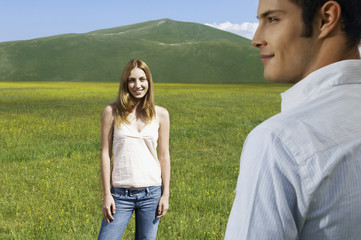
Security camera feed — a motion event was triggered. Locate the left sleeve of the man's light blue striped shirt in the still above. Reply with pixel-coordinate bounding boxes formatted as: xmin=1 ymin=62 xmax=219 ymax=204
xmin=225 ymin=128 xmax=302 ymax=240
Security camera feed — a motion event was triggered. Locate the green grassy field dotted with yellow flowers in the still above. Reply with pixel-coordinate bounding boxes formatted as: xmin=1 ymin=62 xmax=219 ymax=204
xmin=0 ymin=82 xmax=289 ymax=240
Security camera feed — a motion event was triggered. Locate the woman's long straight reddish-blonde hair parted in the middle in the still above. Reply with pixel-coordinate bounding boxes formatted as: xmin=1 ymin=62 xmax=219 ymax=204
xmin=115 ymin=59 xmax=155 ymax=128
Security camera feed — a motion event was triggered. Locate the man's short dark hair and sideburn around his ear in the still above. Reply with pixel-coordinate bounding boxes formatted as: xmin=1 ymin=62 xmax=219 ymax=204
xmin=289 ymin=0 xmax=361 ymax=46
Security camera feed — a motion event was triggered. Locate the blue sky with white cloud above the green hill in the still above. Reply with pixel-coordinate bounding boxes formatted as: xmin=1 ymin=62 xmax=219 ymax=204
xmin=0 ymin=0 xmax=258 ymax=42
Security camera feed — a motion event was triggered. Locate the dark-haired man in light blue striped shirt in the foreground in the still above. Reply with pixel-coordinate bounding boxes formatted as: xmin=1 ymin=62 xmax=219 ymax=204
xmin=225 ymin=0 xmax=361 ymax=240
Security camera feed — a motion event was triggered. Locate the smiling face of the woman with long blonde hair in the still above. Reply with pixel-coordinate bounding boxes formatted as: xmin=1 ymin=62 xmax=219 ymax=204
xmin=128 ymin=68 xmax=149 ymax=99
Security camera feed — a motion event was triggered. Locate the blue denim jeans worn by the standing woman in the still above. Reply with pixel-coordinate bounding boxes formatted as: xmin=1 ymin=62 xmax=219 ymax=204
xmin=98 ymin=186 xmax=162 ymax=240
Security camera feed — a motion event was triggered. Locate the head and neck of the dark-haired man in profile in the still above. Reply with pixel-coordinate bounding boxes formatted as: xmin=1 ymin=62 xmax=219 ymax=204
xmin=252 ymin=0 xmax=360 ymax=83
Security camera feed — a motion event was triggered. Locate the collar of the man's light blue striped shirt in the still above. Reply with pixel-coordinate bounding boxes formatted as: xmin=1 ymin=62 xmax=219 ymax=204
xmin=281 ymin=60 xmax=361 ymax=112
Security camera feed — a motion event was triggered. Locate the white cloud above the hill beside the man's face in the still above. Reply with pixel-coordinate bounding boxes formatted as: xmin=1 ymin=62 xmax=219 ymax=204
xmin=205 ymin=21 xmax=258 ymax=39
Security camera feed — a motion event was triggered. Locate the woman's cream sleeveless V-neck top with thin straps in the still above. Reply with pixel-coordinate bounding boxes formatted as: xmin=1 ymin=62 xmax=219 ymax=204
xmin=112 ymin=118 xmax=162 ymax=188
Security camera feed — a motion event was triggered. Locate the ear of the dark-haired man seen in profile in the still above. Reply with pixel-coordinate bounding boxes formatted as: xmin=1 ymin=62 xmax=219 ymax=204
xmin=318 ymin=1 xmax=341 ymax=39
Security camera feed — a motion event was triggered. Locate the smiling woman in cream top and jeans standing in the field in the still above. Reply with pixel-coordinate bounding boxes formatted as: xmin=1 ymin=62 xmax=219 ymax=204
xmin=98 ymin=60 xmax=170 ymax=240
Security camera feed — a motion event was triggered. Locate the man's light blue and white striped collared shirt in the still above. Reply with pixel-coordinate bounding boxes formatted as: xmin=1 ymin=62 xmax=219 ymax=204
xmin=225 ymin=60 xmax=361 ymax=240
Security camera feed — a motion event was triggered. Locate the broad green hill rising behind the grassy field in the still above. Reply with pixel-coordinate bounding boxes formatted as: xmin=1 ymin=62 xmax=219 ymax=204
xmin=0 ymin=19 xmax=265 ymax=83
